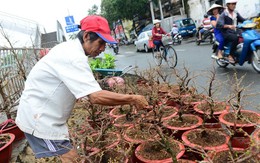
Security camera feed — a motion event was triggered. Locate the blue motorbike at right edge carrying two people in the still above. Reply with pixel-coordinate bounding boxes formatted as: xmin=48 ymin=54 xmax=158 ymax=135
xmin=212 ymin=20 xmax=260 ymax=73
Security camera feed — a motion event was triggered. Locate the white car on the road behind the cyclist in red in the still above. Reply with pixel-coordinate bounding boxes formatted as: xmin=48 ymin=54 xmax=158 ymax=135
xmin=134 ymin=30 xmax=152 ymax=52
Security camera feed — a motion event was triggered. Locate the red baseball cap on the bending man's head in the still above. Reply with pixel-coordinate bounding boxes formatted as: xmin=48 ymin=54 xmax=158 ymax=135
xmin=80 ymin=15 xmax=117 ymax=44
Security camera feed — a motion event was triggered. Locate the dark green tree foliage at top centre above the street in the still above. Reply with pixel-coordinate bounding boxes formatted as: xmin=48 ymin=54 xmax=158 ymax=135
xmin=101 ymin=0 xmax=150 ymax=22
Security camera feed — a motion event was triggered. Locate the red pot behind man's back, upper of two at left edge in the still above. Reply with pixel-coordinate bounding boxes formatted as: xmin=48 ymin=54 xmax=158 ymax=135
xmin=0 ymin=119 xmax=25 ymax=142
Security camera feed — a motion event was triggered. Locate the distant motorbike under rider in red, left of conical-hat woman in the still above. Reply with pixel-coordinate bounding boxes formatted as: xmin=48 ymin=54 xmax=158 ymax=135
xmin=195 ymin=26 xmax=215 ymax=45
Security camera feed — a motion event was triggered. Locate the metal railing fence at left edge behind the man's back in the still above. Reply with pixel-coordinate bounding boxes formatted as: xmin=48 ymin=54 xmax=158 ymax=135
xmin=0 ymin=48 xmax=41 ymax=112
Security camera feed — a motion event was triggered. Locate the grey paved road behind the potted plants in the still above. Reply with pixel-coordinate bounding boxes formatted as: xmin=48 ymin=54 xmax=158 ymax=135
xmin=103 ymin=38 xmax=260 ymax=112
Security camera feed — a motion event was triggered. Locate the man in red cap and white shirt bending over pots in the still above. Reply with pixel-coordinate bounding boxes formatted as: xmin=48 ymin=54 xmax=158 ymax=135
xmin=16 ymin=15 xmax=148 ymax=163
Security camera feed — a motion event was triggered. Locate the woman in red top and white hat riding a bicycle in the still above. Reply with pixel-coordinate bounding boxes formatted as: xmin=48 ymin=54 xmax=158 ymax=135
xmin=152 ymin=19 xmax=168 ymax=52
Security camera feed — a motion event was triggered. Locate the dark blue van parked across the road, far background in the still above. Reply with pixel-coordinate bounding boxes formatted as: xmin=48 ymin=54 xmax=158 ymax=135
xmin=174 ymin=18 xmax=197 ymax=37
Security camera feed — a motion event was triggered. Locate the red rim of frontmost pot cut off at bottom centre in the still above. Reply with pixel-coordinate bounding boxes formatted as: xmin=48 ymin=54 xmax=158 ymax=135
xmin=135 ymin=139 xmax=185 ymax=163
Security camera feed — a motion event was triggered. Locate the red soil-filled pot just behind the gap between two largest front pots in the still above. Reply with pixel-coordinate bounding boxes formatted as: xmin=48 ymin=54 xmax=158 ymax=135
xmin=163 ymin=114 xmax=203 ymax=140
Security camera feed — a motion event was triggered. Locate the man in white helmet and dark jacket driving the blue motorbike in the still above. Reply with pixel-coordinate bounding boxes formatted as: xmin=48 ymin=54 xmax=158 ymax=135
xmin=217 ymin=0 xmax=246 ymax=64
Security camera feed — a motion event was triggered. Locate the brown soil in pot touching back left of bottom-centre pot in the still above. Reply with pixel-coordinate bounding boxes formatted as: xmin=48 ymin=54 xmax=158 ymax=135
xmin=124 ymin=123 xmax=159 ymax=144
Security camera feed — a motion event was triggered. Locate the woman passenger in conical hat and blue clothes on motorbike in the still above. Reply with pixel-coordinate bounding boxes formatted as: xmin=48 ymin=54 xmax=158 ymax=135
xmin=207 ymin=4 xmax=224 ymax=59
